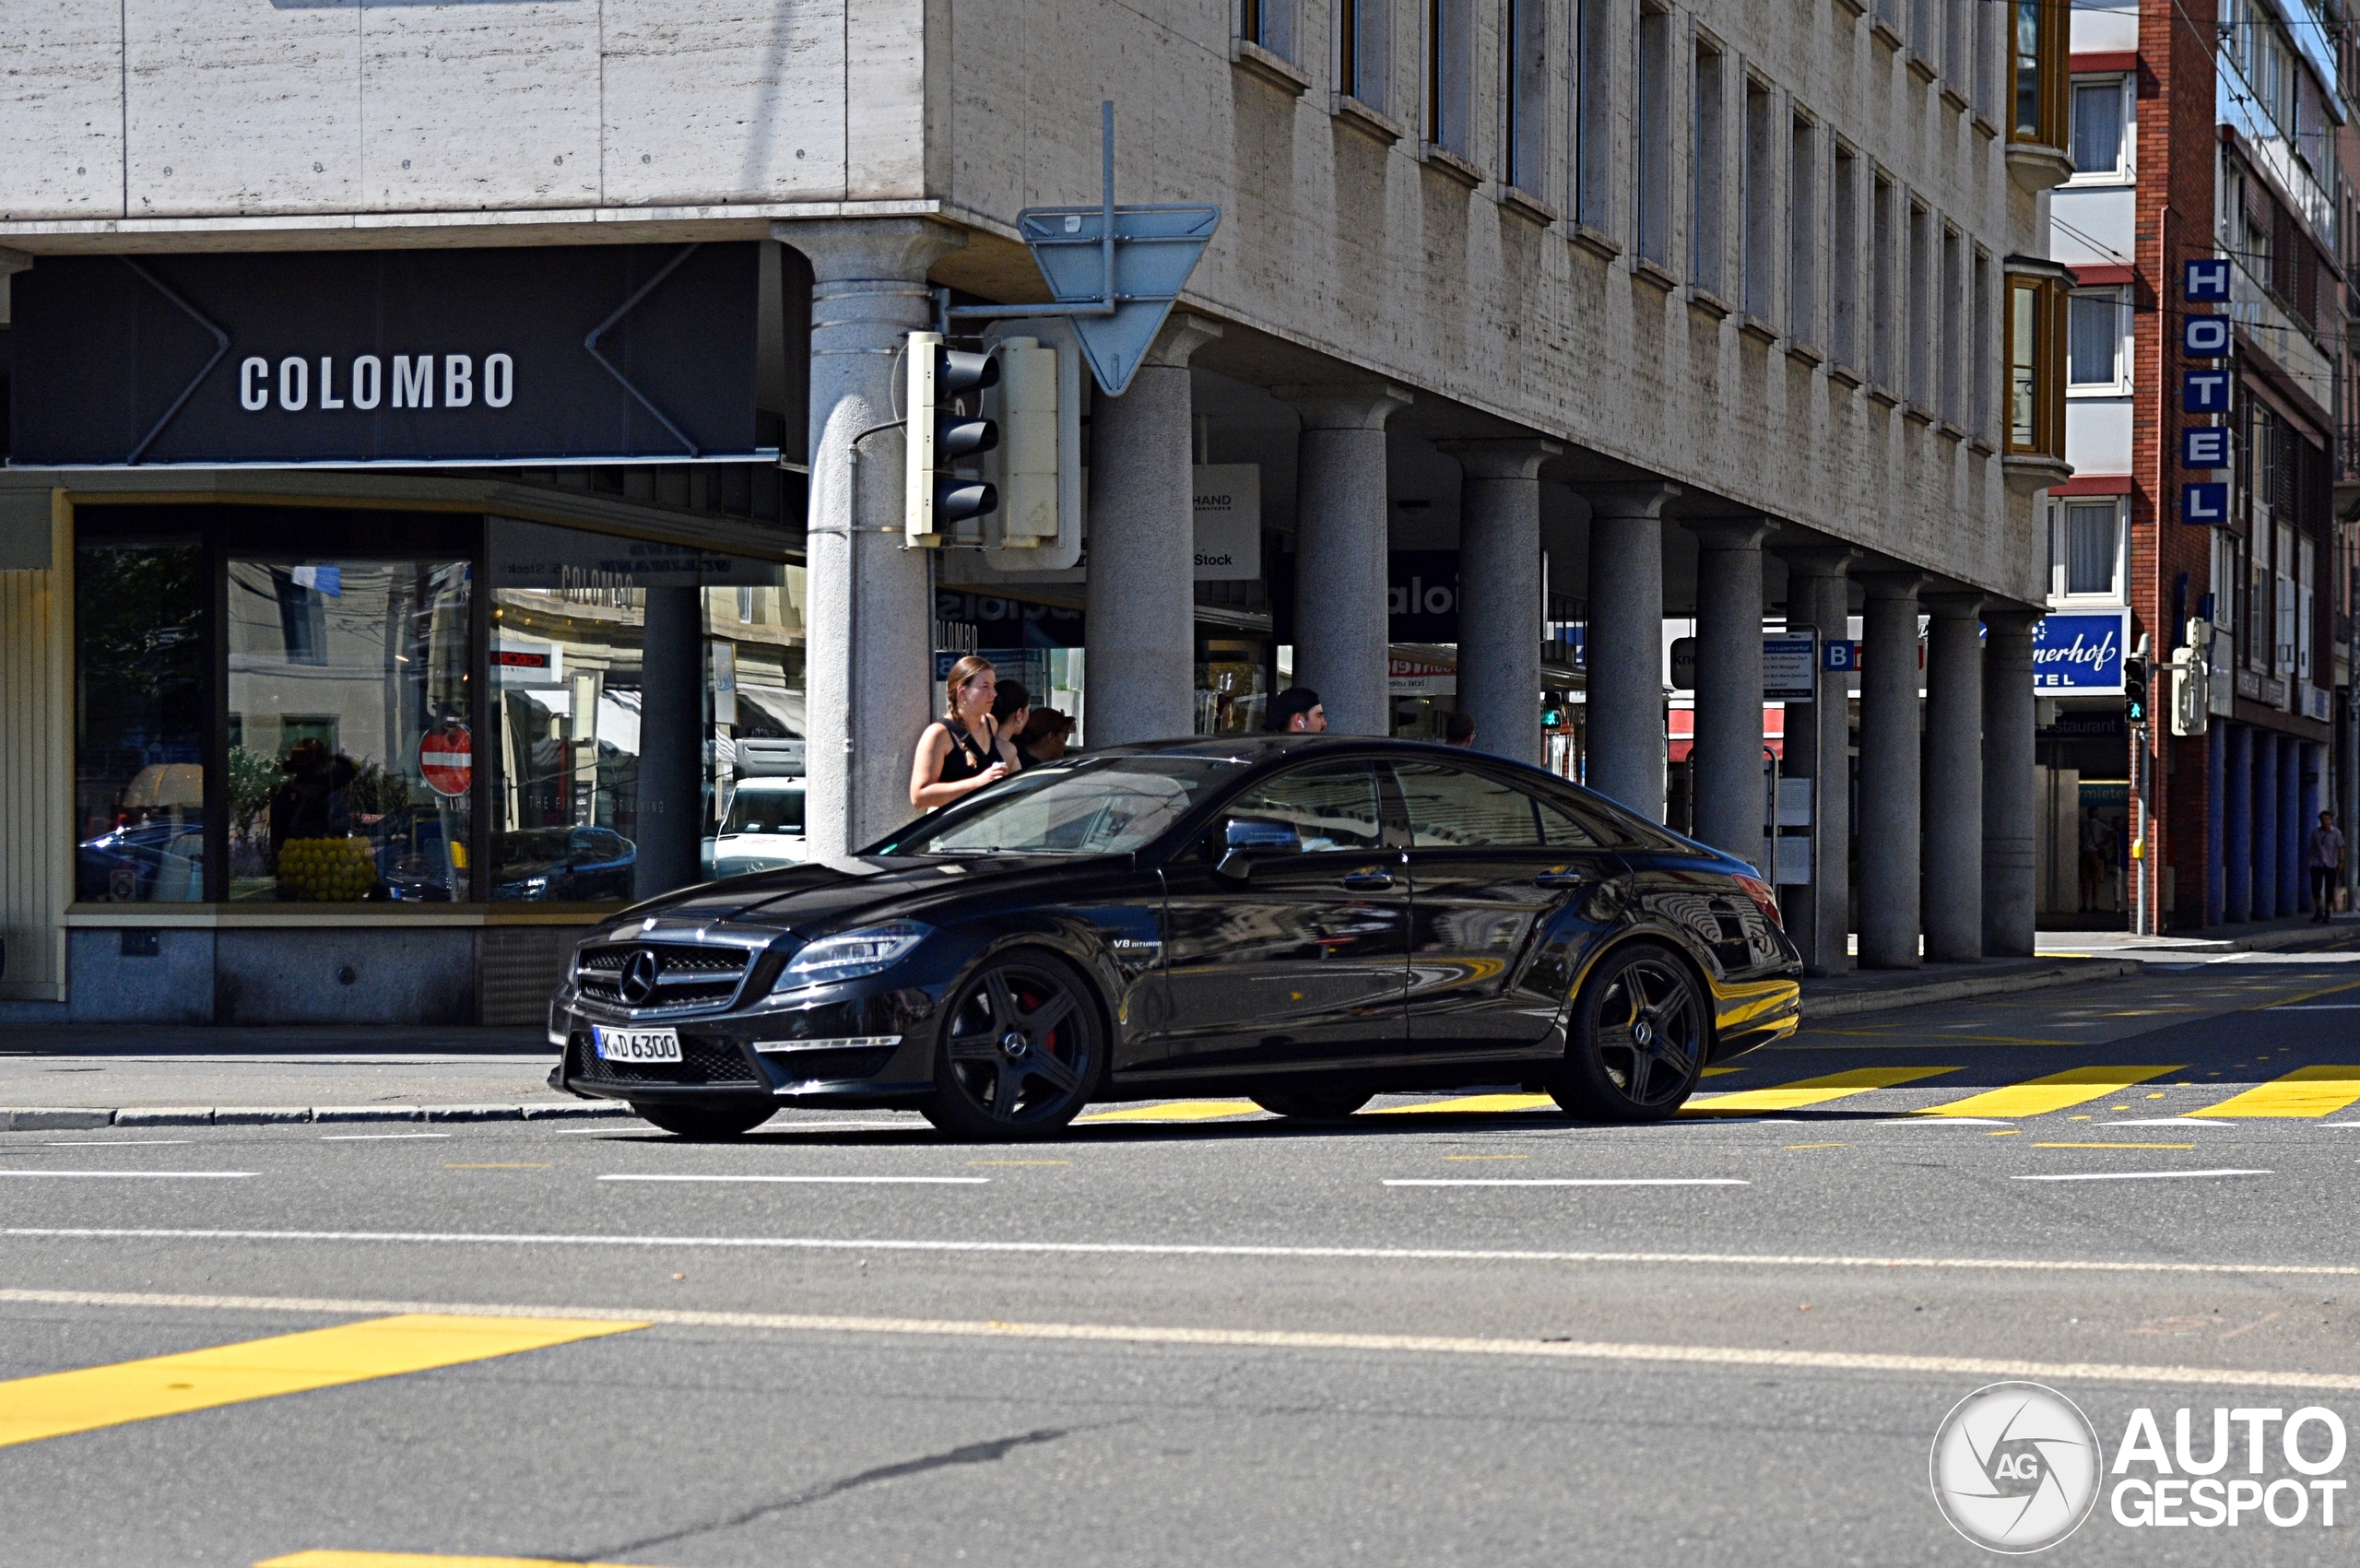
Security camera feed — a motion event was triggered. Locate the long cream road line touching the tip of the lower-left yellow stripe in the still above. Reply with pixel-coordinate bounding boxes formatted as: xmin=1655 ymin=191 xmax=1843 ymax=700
xmin=0 ymin=1291 xmax=2360 ymax=1397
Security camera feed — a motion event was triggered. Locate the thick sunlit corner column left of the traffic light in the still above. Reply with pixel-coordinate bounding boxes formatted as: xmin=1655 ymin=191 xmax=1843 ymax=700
xmin=772 ymin=218 xmax=965 ymax=859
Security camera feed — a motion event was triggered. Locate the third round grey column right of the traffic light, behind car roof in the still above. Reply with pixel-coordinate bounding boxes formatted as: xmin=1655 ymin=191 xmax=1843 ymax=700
xmin=1440 ymin=439 xmax=1564 ymax=768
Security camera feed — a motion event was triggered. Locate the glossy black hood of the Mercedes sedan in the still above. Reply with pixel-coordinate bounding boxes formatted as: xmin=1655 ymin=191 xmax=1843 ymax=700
xmin=608 ymin=855 xmax=1130 ymax=937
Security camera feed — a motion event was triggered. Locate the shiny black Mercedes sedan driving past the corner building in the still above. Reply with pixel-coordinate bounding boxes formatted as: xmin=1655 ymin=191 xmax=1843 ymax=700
xmin=549 ymin=735 xmax=1800 ymax=1138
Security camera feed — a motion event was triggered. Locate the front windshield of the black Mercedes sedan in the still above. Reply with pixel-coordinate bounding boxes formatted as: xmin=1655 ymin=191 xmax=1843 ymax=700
xmin=878 ymin=756 xmax=1239 ymax=855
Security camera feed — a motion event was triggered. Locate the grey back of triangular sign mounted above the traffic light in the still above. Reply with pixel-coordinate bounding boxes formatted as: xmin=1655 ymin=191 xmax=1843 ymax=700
xmin=1017 ymin=206 xmax=1221 ymax=396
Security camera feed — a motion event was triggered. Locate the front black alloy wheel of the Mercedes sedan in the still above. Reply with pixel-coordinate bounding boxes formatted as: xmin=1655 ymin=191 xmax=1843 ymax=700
xmin=920 ymin=951 xmax=1104 ymax=1140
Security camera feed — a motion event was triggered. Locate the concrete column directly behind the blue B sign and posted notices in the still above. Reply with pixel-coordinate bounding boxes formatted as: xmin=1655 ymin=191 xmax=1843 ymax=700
xmin=1779 ymin=546 xmax=1859 ymax=975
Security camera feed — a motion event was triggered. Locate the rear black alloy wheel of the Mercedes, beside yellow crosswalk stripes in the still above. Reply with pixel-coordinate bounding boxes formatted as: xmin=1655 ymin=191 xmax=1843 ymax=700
xmin=1548 ymin=942 xmax=1708 ymax=1122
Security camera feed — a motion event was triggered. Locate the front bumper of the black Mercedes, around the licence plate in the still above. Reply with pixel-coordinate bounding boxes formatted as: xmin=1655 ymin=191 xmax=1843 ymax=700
xmin=549 ymin=978 xmax=939 ymax=1105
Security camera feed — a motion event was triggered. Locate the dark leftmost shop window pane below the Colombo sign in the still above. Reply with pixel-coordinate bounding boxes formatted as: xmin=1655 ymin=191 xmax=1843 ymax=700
xmin=73 ymin=543 xmax=206 ymax=904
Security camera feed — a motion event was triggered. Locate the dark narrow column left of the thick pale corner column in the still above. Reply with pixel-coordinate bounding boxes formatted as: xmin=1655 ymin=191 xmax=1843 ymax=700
xmin=631 ymin=588 xmax=705 ymax=897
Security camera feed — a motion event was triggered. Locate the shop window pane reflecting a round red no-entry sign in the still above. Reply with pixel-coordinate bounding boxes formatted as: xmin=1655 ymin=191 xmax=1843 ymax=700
xmin=229 ymin=560 xmax=475 ymax=902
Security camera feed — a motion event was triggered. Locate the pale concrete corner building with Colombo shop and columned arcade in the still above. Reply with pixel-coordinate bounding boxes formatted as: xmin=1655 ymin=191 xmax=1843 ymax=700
xmin=0 ymin=0 xmax=2070 ymax=1020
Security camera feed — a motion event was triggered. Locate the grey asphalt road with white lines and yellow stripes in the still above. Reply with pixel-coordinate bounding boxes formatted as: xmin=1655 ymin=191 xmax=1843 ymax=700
xmin=0 ymin=954 xmax=2360 ymax=1568
